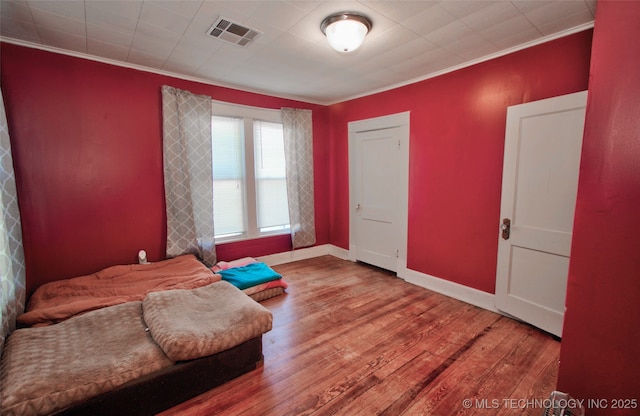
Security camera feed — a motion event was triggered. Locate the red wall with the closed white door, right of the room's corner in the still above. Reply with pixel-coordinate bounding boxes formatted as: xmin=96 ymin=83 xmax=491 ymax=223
xmin=329 ymin=31 xmax=591 ymax=293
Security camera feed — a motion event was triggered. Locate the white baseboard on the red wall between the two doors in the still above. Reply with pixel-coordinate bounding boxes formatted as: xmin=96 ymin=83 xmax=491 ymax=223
xmin=398 ymin=268 xmax=501 ymax=313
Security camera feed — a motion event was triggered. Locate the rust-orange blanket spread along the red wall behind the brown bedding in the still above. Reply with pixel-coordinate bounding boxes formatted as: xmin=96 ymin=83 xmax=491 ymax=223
xmin=17 ymin=254 xmax=220 ymax=326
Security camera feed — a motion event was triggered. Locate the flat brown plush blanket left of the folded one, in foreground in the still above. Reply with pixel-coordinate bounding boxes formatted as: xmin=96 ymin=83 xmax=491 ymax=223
xmin=0 ymin=301 xmax=173 ymax=416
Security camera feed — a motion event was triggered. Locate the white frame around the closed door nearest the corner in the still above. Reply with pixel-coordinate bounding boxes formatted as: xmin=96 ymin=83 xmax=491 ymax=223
xmin=348 ymin=111 xmax=411 ymax=273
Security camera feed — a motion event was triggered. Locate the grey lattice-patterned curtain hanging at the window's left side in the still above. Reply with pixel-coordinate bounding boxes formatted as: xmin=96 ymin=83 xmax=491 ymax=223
xmin=162 ymin=85 xmax=216 ymax=266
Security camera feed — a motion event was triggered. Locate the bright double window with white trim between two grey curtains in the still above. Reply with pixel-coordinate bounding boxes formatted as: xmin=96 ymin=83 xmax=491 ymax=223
xmin=211 ymin=102 xmax=289 ymax=241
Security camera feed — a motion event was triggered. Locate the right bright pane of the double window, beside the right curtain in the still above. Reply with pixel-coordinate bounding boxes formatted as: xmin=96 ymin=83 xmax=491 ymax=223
xmin=253 ymin=121 xmax=289 ymax=232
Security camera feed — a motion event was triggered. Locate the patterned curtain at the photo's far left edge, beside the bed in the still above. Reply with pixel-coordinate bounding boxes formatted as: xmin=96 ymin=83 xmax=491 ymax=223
xmin=0 ymin=86 xmax=26 ymax=355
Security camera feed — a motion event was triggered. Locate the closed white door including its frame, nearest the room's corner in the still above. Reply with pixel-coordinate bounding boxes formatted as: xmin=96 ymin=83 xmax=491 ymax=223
xmin=349 ymin=113 xmax=409 ymax=271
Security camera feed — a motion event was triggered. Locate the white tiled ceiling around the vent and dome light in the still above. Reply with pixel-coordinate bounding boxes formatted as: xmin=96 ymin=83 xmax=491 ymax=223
xmin=0 ymin=0 xmax=596 ymax=104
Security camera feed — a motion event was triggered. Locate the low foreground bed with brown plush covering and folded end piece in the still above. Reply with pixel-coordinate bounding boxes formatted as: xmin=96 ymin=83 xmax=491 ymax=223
xmin=0 ymin=281 xmax=272 ymax=416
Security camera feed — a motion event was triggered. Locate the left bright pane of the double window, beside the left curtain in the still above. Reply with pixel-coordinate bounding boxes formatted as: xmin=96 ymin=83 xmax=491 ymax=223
xmin=211 ymin=117 xmax=246 ymax=237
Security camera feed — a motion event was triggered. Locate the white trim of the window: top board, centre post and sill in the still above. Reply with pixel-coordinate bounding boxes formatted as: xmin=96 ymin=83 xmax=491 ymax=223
xmin=211 ymin=100 xmax=291 ymax=243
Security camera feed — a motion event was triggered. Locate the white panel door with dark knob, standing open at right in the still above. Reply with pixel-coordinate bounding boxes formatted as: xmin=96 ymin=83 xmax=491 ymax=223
xmin=496 ymin=91 xmax=587 ymax=336
